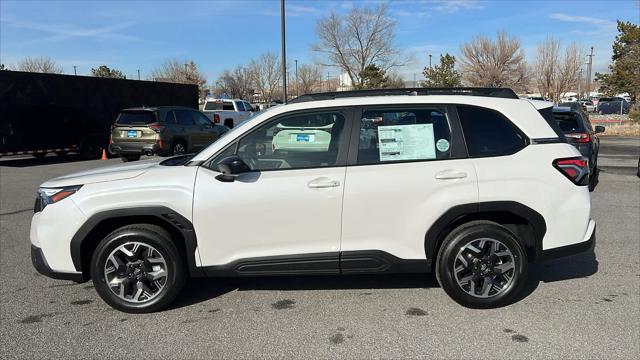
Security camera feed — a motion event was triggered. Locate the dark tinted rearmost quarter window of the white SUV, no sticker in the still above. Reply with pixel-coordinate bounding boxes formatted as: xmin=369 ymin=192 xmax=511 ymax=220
xmin=458 ymin=106 xmax=526 ymax=157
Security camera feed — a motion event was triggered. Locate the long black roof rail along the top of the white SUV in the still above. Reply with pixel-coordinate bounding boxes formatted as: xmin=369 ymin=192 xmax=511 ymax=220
xmin=289 ymin=87 xmax=518 ymax=104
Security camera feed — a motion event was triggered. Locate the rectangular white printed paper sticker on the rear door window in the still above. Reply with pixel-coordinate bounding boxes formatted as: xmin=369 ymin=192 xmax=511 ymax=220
xmin=378 ymin=124 xmax=436 ymax=161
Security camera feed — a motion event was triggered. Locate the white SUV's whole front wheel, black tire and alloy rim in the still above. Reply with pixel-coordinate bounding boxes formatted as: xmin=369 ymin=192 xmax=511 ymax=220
xmin=91 ymin=224 xmax=186 ymax=313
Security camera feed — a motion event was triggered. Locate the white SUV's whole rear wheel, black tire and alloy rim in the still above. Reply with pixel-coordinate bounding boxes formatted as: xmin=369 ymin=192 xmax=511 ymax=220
xmin=436 ymin=221 xmax=527 ymax=308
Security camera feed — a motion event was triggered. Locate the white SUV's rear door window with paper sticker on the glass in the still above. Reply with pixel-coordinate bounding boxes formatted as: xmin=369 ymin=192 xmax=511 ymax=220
xmin=358 ymin=108 xmax=451 ymax=164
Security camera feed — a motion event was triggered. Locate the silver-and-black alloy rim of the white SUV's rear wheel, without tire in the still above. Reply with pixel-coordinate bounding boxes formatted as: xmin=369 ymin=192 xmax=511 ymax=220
xmin=454 ymin=238 xmax=516 ymax=298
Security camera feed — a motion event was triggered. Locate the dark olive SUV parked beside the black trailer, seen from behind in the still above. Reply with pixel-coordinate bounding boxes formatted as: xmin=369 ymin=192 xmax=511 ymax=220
xmin=109 ymin=106 xmax=222 ymax=161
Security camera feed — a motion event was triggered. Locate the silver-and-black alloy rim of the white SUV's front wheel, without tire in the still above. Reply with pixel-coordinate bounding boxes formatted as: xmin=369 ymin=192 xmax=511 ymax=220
xmin=104 ymin=242 xmax=168 ymax=303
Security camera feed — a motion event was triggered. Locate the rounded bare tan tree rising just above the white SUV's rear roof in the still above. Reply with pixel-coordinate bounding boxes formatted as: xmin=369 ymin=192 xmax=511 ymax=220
xmin=460 ymin=31 xmax=528 ymax=89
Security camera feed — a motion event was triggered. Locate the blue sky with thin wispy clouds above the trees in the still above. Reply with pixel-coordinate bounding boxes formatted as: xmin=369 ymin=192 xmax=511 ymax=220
xmin=0 ymin=0 xmax=640 ymax=82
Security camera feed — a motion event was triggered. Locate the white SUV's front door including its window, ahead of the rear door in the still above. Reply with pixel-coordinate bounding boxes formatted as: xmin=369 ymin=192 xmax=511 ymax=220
xmin=193 ymin=110 xmax=349 ymax=273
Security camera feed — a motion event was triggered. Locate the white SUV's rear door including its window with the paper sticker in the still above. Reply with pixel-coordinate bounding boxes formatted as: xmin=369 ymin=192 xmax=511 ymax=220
xmin=341 ymin=105 xmax=478 ymax=262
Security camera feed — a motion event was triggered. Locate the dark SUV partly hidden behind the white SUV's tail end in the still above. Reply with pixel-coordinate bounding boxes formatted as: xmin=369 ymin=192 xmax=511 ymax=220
xmin=553 ymin=104 xmax=605 ymax=191
